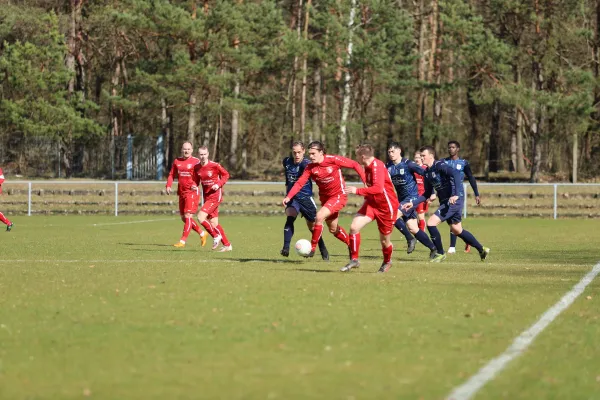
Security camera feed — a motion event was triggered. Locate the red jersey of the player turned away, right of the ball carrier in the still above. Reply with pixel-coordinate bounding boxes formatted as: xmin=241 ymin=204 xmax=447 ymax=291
xmin=356 ymin=159 xmax=399 ymax=215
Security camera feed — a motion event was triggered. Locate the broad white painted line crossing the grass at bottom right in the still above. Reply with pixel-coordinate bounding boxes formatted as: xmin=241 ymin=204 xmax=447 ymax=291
xmin=446 ymin=262 xmax=600 ymax=400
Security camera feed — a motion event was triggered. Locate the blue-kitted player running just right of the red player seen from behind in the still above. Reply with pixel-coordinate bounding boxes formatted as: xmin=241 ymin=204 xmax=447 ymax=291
xmin=387 ymin=142 xmax=437 ymax=258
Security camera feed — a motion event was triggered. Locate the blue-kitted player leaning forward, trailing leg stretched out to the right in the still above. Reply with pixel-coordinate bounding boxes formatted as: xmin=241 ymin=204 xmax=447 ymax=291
xmin=402 ymin=146 xmax=490 ymax=262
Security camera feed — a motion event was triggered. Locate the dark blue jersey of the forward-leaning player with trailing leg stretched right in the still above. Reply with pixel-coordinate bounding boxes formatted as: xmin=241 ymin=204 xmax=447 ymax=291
xmin=413 ymin=160 xmax=462 ymax=207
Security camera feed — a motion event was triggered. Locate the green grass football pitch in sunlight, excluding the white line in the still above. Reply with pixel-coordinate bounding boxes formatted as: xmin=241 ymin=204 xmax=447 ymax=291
xmin=0 ymin=216 xmax=600 ymax=399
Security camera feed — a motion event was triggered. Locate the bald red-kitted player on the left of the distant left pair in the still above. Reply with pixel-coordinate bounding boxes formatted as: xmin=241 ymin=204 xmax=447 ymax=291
xmin=166 ymin=142 xmax=206 ymax=247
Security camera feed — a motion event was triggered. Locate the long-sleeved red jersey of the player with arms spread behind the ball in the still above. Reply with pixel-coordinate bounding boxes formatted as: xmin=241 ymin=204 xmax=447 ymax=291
xmin=287 ymin=155 xmax=365 ymax=199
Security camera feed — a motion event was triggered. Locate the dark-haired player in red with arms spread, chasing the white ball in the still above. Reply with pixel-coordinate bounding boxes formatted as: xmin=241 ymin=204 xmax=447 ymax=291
xmin=283 ymin=140 xmax=365 ymax=257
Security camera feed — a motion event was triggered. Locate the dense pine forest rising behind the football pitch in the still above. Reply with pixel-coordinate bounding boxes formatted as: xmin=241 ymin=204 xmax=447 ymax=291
xmin=0 ymin=0 xmax=600 ymax=182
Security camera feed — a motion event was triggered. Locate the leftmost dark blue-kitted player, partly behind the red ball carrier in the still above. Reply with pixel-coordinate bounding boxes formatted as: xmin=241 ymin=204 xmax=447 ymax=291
xmin=281 ymin=141 xmax=329 ymax=261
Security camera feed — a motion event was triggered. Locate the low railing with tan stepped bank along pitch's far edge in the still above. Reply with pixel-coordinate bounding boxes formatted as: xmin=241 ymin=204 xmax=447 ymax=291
xmin=0 ymin=180 xmax=600 ymax=219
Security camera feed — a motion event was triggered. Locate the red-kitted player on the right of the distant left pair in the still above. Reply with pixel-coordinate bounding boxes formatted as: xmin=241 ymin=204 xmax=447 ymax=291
xmin=194 ymin=146 xmax=232 ymax=252
